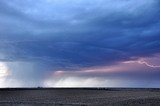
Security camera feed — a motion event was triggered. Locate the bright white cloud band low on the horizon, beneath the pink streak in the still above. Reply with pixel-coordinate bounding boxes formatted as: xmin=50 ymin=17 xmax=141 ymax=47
xmin=44 ymin=76 xmax=124 ymax=87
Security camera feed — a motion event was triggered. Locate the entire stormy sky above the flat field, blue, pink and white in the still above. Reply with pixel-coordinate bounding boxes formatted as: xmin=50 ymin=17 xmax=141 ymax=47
xmin=0 ymin=0 xmax=160 ymax=88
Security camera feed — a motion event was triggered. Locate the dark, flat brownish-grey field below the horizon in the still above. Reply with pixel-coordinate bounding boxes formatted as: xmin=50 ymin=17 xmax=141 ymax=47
xmin=0 ymin=88 xmax=160 ymax=106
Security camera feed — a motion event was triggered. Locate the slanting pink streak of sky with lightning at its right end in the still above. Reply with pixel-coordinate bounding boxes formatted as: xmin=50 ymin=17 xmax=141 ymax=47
xmin=50 ymin=55 xmax=160 ymax=77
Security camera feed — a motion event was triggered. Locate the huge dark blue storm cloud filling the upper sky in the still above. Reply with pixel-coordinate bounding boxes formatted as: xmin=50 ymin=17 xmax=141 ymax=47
xmin=0 ymin=0 xmax=160 ymax=70
